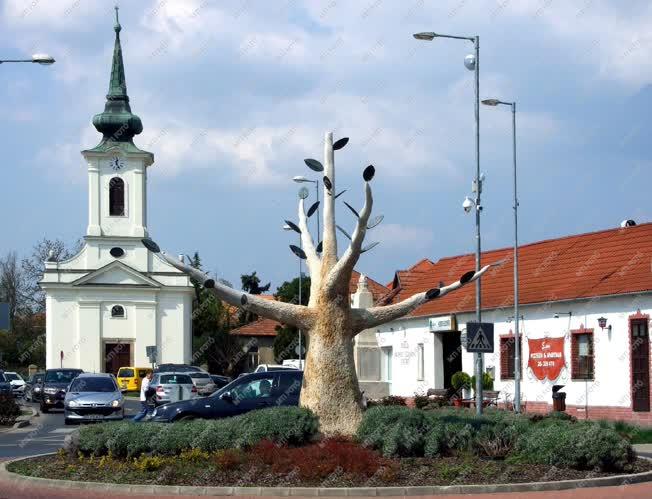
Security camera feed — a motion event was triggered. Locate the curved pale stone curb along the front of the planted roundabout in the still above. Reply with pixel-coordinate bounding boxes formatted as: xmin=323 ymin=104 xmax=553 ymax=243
xmin=0 ymin=453 xmax=652 ymax=497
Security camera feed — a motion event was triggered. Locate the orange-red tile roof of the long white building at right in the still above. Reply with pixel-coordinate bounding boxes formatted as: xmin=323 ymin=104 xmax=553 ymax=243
xmin=386 ymin=223 xmax=652 ymax=316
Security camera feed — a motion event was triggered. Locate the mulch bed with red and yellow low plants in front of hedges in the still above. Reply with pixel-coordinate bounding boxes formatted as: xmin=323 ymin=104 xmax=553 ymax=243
xmin=9 ymin=451 xmax=652 ymax=487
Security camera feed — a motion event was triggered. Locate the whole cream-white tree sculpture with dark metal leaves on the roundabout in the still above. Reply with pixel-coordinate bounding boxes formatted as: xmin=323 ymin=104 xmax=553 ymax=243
xmin=143 ymin=133 xmax=491 ymax=435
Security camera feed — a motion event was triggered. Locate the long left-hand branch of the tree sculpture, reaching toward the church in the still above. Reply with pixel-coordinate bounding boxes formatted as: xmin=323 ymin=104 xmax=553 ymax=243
xmin=152 ymin=241 xmax=314 ymax=329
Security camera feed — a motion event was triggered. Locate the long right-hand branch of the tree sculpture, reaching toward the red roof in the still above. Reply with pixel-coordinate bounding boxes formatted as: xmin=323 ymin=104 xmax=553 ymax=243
xmin=351 ymin=262 xmax=502 ymax=334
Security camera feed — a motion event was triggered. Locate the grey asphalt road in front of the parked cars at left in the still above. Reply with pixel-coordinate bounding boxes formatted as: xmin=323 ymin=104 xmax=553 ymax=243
xmin=0 ymin=398 xmax=140 ymax=460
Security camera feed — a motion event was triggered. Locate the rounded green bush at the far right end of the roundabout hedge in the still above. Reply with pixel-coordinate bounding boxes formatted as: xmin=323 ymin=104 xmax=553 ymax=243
xmin=515 ymin=421 xmax=634 ymax=471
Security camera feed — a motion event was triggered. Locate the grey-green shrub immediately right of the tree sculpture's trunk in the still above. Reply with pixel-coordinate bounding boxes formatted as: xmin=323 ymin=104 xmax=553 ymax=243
xmin=357 ymin=407 xmax=428 ymax=456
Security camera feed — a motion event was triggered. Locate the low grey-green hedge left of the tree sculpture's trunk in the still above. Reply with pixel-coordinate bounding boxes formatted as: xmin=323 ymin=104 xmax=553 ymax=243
xmin=76 ymin=407 xmax=319 ymax=457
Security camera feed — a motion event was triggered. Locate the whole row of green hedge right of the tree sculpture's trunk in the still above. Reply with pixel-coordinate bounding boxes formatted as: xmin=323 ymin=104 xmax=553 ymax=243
xmin=357 ymin=407 xmax=634 ymax=471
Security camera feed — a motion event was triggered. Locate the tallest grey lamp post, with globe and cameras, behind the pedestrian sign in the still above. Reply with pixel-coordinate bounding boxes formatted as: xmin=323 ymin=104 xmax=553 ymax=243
xmin=412 ymin=31 xmax=484 ymax=415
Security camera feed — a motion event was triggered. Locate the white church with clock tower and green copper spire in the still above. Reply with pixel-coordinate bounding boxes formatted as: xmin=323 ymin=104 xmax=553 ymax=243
xmin=40 ymin=8 xmax=194 ymax=373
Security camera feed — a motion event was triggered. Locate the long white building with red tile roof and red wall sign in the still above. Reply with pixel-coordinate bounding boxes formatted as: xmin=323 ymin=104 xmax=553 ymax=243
xmin=356 ymin=224 xmax=652 ymax=424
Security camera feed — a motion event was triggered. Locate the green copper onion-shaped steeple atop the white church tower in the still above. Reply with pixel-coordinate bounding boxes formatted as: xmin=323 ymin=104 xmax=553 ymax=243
xmin=93 ymin=6 xmax=143 ymax=145
